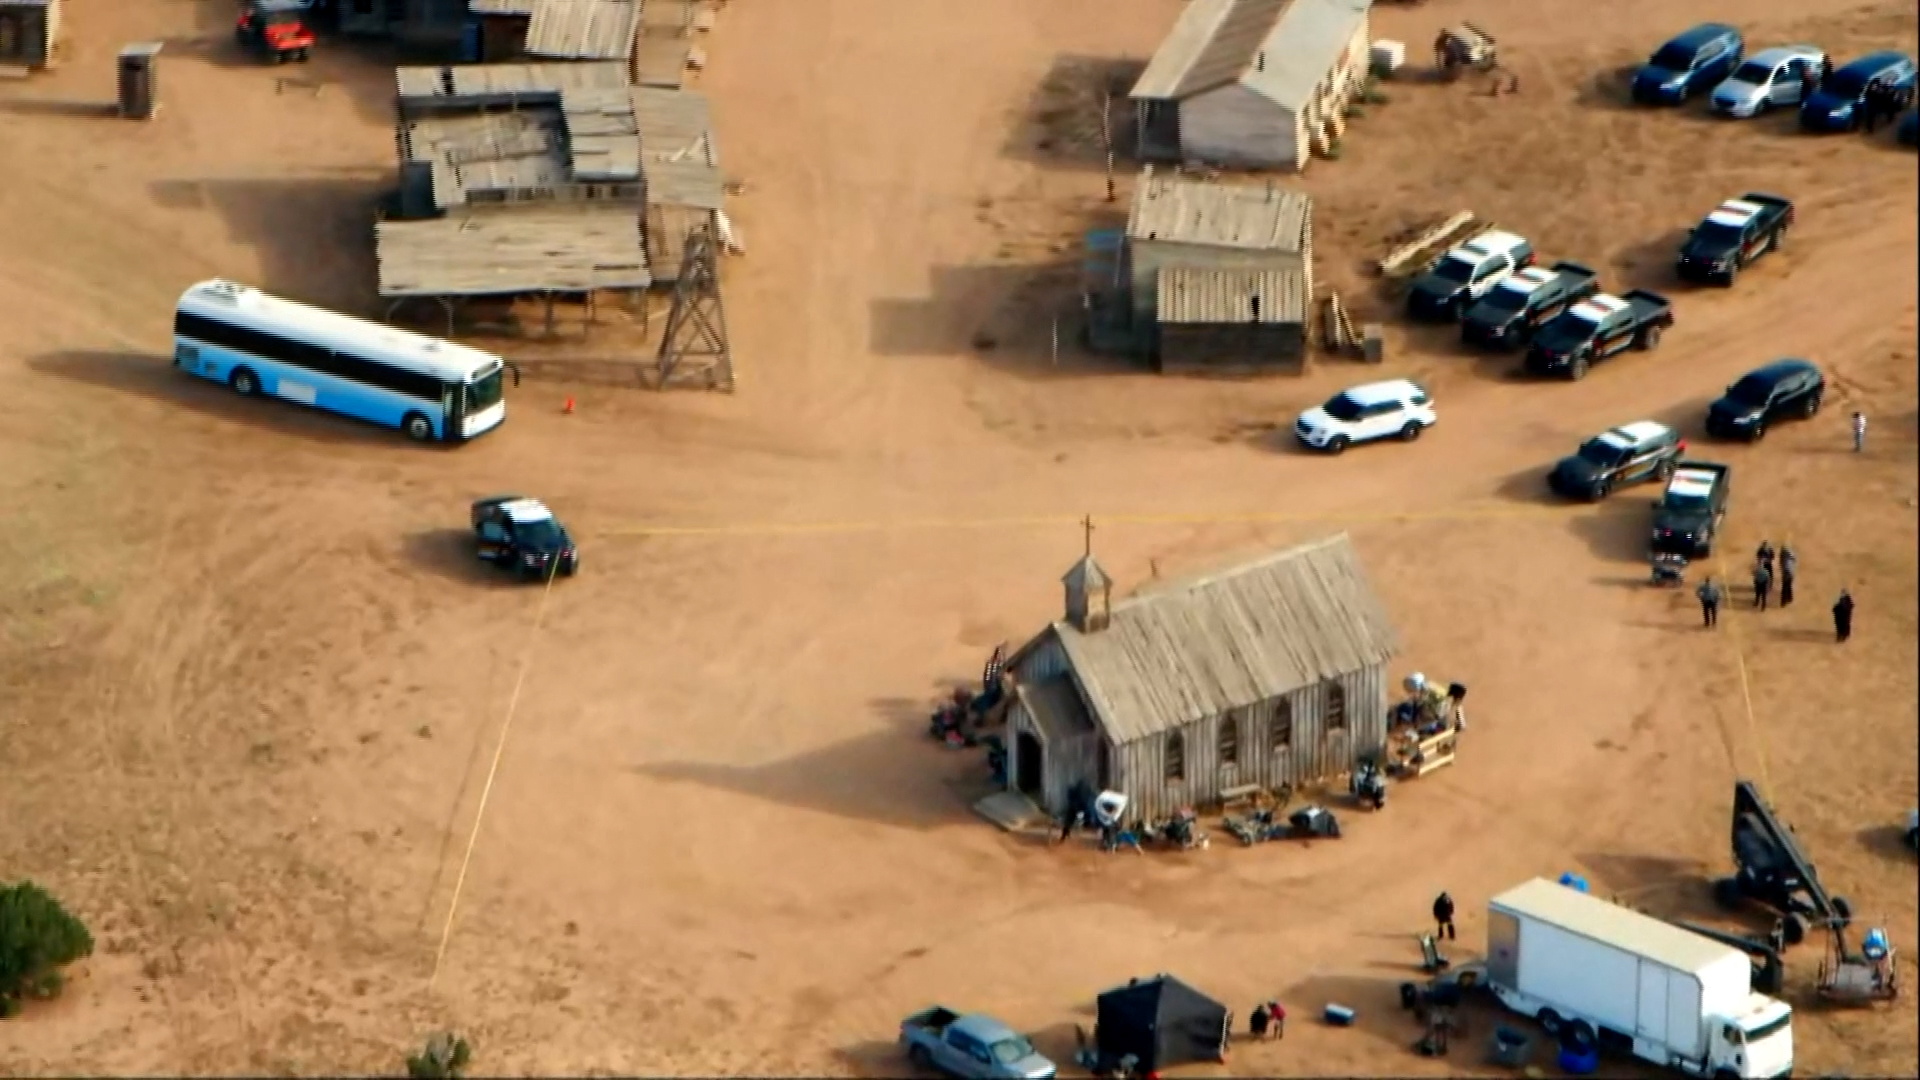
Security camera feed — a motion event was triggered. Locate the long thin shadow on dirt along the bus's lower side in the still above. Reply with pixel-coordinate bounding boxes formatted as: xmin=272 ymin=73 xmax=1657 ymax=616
xmin=27 ymin=350 xmax=409 ymax=446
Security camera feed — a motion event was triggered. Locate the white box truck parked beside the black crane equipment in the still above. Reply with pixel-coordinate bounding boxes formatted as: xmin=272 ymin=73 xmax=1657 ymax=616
xmin=1486 ymin=878 xmax=1793 ymax=1080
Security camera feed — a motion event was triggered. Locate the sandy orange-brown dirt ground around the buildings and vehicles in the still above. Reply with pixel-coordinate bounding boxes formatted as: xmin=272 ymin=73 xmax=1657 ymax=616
xmin=0 ymin=0 xmax=1920 ymax=1076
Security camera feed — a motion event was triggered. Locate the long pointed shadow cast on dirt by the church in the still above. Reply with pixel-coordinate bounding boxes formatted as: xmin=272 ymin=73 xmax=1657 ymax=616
xmin=634 ymin=696 xmax=991 ymax=830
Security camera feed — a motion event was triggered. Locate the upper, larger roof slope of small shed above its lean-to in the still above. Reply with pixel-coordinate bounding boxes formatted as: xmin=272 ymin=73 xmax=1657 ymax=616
xmin=1127 ymin=169 xmax=1313 ymax=252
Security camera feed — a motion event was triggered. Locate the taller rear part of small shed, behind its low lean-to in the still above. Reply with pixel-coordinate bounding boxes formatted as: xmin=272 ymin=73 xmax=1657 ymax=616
xmin=1127 ymin=165 xmax=1313 ymax=331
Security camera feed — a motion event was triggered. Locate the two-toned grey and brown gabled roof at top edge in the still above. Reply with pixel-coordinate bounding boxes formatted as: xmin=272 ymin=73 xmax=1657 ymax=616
xmin=1131 ymin=0 xmax=1373 ymax=108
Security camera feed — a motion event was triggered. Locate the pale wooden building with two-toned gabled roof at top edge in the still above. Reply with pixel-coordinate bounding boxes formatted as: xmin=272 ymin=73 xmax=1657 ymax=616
xmin=1129 ymin=0 xmax=1373 ymax=169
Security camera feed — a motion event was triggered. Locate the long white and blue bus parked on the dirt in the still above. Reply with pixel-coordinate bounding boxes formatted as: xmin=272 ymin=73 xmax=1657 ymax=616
xmin=173 ymin=281 xmax=518 ymax=442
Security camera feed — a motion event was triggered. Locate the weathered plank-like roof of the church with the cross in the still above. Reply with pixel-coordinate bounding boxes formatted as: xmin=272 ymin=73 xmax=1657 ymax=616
xmin=1050 ymin=534 xmax=1400 ymax=742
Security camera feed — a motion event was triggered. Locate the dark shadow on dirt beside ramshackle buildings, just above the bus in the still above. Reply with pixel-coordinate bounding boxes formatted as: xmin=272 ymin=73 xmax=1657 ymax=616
xmin=150 ymin=171 xmax=388 ymax=311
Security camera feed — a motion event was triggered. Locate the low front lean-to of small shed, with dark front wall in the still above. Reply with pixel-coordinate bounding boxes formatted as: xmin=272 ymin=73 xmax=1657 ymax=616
xmin=1154 ymin=267 xmax=1308 ymax=371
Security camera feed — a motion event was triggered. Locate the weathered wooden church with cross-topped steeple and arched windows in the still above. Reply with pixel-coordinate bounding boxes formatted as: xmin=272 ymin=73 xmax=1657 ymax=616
xmin=1006 ymin=534 xmax=1400 ymax=821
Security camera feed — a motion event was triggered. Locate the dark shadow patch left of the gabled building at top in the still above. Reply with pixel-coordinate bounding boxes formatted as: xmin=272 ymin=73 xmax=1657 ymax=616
xmin=1002 ymin=54 xmax=1146 ymax=171
